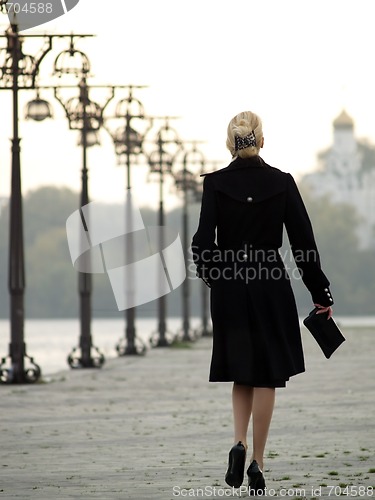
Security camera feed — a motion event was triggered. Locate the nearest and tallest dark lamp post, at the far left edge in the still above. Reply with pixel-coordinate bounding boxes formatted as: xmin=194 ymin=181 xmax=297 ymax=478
xmin=0 ymin=12 xmax=90 ymax=383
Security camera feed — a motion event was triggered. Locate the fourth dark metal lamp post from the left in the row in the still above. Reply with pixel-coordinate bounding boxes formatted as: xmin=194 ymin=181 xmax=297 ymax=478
xmin=148 ymin=116 xmax=182 ymax=347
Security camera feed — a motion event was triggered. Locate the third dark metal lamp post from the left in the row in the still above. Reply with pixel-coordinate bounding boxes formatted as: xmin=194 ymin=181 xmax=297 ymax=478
xmin=106 ymin=85 xmax=150 ymax=356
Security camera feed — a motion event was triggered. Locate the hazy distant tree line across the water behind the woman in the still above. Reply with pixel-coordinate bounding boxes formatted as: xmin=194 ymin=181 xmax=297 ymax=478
xmin=0 ymin=187 xmax=375 ymax=318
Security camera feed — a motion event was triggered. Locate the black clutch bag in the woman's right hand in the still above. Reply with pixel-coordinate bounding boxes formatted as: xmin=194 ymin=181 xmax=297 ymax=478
xmin=303 ymin=307 xmax=345 ymax=359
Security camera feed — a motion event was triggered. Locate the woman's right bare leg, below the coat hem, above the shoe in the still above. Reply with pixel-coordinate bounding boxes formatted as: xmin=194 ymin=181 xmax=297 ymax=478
xmin=251 ymin=387 xmax=275 ymax=470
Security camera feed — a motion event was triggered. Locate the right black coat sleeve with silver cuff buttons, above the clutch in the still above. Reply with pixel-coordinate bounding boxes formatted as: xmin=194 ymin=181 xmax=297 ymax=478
xmin=285 ymin=174 xmax=333 ymax=307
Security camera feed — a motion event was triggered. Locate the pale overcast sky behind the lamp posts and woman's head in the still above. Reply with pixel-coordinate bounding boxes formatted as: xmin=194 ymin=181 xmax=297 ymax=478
xmin=0 ymin=0 xmax=375 ymax=207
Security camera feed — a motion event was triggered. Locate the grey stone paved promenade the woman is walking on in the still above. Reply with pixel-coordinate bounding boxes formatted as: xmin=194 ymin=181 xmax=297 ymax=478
xmin=0 ymin=329 xmax=375 ymax=500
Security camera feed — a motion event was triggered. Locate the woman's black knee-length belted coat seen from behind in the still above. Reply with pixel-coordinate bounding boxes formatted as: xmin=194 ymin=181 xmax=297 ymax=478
xmin=192 ymin=156 xmax=333 ymax=387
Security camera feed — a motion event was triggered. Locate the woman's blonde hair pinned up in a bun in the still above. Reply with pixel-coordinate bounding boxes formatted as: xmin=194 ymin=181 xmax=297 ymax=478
xmin=226 ymin=111 xmax=263 ymax=158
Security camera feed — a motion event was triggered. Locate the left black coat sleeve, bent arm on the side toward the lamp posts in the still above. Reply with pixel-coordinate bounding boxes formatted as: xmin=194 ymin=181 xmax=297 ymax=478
xmin=191 ymin=176 xmax=217 ymax=286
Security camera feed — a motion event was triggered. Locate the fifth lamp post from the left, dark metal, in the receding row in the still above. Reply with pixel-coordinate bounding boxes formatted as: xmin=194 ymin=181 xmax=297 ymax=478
xmin=174 ymin=141 xmax=205 ymax=342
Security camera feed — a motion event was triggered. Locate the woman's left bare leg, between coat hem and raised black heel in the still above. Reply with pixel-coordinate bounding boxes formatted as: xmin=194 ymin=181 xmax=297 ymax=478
xmin=232 ymin=383 xmax=254 ymax=448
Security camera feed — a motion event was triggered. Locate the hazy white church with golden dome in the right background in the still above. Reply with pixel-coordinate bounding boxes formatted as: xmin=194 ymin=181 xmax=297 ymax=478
xmin=302 ymin=111 xmax=375 ymax=249
